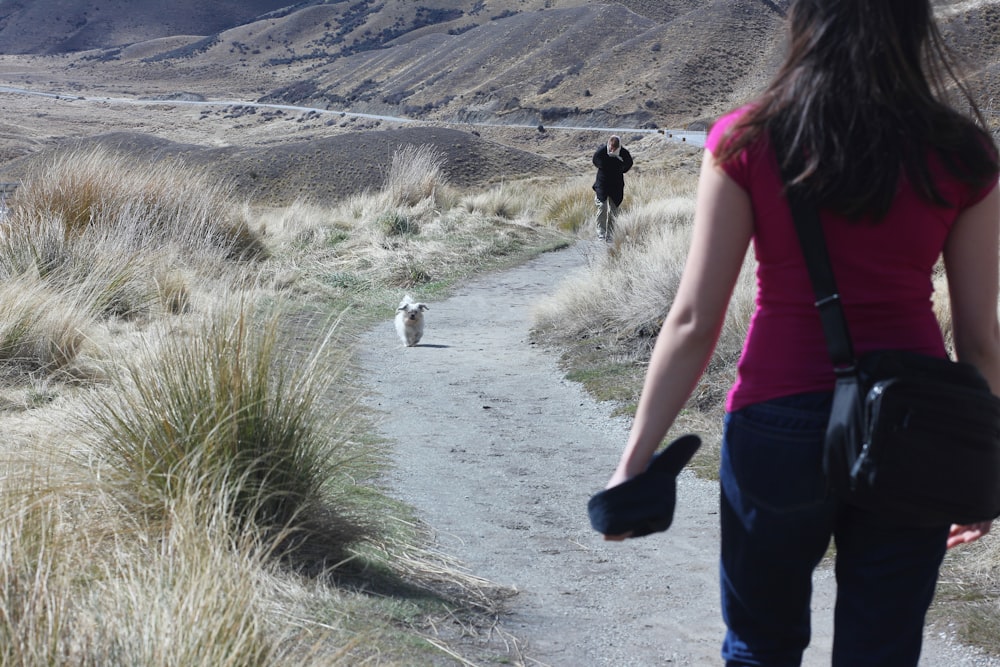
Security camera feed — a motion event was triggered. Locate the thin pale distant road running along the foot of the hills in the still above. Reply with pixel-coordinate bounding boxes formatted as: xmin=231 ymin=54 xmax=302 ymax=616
xmin=0 ymin=86 xmax=705 ymax=146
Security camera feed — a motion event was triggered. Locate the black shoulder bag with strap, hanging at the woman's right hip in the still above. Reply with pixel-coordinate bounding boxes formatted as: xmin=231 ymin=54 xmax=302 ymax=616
xmin=788 ymin=187 xmax=1000 ymax=525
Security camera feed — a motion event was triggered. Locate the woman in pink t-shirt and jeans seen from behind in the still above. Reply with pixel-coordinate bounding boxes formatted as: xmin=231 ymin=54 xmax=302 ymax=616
xmin=608 ymin=0 xmax=1000 ymax=667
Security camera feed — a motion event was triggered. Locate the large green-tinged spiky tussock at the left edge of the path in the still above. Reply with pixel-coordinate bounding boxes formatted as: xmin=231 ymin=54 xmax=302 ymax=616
xmin=84 ymin=309 xmax=372 ymax=558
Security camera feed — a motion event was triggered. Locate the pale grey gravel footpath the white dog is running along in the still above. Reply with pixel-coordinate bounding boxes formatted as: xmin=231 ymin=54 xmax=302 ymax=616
xmin=361 ymin=243 xmax=1000 ymax=667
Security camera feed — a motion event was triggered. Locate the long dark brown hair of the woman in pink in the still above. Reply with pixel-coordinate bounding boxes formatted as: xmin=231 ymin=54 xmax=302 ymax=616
xmin=715 ymin=0 xmax=997 ymax=219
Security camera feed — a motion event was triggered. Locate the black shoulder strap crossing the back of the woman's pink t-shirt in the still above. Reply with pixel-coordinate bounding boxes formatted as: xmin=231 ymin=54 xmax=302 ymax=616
xmin=783 ymin=179 xmax=856 ymax=377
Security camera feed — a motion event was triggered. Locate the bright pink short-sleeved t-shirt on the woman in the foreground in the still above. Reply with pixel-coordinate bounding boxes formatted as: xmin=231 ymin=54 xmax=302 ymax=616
xmin=705 ymin=110 xmax=996 ymax=411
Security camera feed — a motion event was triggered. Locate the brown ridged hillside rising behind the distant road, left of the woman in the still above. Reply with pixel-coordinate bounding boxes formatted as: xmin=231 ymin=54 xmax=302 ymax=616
xmin=0 ymin=0 xmax=783 ymax=127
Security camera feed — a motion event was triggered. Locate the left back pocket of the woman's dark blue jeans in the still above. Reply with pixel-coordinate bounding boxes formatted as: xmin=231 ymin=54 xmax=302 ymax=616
xmin=719 ymin=402 xmax=829 ymax=513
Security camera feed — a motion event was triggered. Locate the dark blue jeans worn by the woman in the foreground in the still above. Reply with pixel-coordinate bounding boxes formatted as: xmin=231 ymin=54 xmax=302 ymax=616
xmin=719 ymin=393 xmax=948 ymax=667
